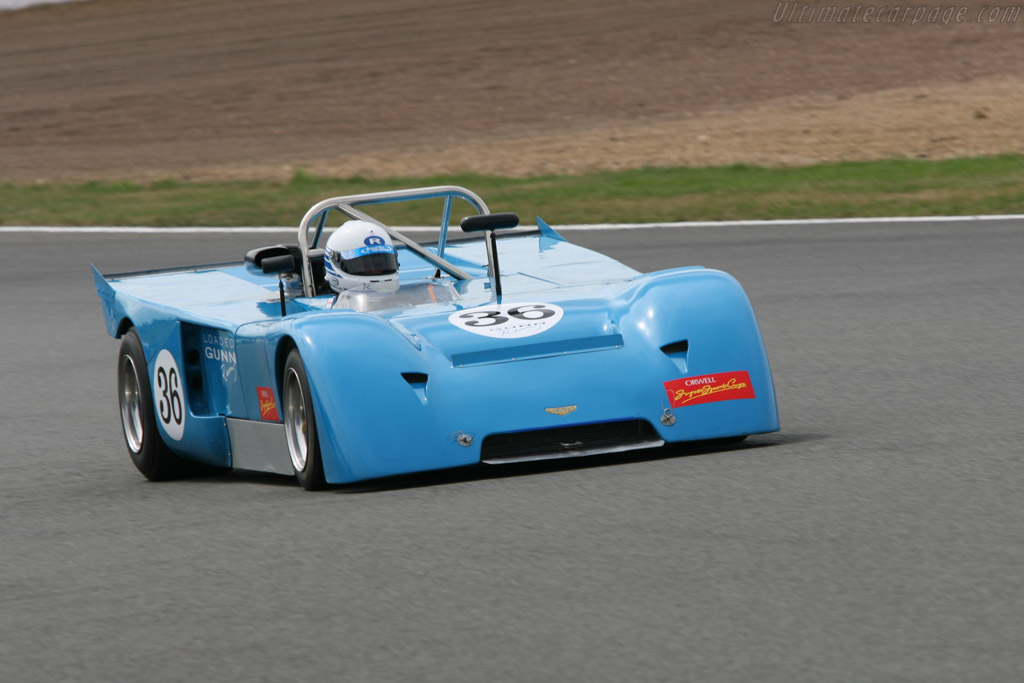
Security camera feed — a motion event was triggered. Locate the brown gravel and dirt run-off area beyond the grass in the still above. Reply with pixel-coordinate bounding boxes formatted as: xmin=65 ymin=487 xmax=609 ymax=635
xmin=0 ymin=0 xmax=1024 ymax=183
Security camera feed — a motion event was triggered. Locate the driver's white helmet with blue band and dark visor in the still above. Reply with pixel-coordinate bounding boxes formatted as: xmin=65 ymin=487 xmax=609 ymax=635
xmin=324 ymin=220 xmax=398 ymax=294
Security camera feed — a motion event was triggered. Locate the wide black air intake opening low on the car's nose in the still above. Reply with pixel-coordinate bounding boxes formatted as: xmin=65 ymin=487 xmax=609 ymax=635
xmin=480 ymin=420 xmax=665 ymax=464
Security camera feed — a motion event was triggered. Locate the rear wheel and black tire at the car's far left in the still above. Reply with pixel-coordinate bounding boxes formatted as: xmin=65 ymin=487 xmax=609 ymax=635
xmin=118 ymin=328 xmax=187 ymax=481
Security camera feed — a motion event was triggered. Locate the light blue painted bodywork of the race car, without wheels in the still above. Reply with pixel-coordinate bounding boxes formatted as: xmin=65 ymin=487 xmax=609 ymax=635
xmin=93 ymin=192 xmax=778 ymax=483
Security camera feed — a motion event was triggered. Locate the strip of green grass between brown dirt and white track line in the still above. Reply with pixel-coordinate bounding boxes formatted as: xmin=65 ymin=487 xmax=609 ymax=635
xmin=0 ymin=155 xmax=1024 ymax=226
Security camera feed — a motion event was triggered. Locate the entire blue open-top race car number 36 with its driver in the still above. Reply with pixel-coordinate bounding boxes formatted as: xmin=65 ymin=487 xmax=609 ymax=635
xmin=93 ymin=186 xmax=778 ymax=489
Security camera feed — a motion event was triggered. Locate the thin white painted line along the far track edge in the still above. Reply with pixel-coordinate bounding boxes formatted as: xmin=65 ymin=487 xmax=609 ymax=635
xmin=0 ymin=214 xmax=1024 ymax=234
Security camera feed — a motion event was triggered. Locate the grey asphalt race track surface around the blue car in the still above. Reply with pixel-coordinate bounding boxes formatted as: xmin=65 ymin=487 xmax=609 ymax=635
xmin=0 ymin=220 xmax=1024 ymax=682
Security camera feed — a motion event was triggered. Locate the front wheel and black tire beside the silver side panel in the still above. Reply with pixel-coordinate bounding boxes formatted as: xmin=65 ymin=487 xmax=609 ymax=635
xmin=281 ymin=348 xmax=327 ymax=490
